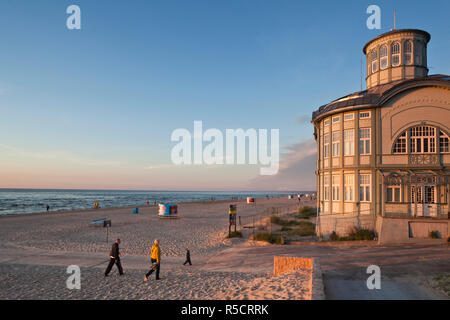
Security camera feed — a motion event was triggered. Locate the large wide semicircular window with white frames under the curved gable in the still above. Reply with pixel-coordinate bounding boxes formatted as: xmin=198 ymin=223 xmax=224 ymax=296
xmin=392 ymin=126 xmax=450 ymax=154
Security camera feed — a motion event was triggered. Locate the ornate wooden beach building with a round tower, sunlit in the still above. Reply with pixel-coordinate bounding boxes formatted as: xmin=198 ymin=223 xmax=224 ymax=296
xmin=312 ymin=29 xmax=450 ymax=242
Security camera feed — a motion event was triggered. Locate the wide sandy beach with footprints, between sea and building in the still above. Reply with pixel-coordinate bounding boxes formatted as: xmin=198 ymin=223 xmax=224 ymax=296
xmin=0 ymin=198 xmax=311 ymax=300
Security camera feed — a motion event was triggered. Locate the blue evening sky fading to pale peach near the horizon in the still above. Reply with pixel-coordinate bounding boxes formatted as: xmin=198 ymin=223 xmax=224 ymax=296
xmin=0 ymin=0 xmax=450 ymax=191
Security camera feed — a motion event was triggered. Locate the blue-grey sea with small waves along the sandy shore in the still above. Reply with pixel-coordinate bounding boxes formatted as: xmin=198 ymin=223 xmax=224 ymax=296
xmin=0 ymin=189 xmax=306 ymax=215
